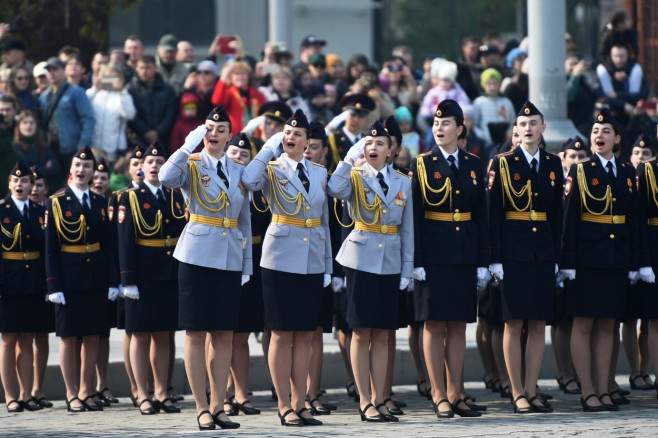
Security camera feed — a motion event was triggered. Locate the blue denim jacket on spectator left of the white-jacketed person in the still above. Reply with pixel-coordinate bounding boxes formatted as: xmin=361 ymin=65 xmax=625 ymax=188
xmin=39 ymin=84 xmax=96 ymax=155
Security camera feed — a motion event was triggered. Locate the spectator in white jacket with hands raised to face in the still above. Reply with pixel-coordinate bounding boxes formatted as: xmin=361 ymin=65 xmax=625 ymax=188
xmin=87 ymin=64 xmax=137 ymax=165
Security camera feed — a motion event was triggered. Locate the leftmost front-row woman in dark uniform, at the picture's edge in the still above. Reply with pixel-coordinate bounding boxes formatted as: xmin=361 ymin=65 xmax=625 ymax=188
xmin=0 ymin=161 xmax=46 ymax=412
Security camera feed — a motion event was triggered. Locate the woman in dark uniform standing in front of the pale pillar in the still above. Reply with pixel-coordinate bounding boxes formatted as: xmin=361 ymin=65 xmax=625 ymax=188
xmin=489 ymin=101 xmax=562 ymax=413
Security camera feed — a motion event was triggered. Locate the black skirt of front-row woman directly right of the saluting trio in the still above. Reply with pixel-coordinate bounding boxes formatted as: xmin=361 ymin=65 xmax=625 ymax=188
xmin=415 ymin=265 xmax=477 ymax=322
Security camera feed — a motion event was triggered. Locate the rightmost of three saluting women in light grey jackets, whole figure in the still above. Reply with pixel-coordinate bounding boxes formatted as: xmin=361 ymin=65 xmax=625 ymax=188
xmin=329 ymin=122 xmax=414 ymax=422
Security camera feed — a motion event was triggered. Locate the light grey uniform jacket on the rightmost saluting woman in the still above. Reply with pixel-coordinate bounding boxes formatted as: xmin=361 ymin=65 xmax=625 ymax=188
xmin=327 ymin=161 xmax=414 ymax=277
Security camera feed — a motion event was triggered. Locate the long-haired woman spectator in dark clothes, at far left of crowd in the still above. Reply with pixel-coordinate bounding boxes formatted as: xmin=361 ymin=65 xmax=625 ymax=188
xmin=13 ymin=110 xmax=60 ymax=179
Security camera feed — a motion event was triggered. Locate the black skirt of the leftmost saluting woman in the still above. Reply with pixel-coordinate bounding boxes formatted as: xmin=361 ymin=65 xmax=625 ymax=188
xmin=178 ymin=262 xmax=242 ymax=331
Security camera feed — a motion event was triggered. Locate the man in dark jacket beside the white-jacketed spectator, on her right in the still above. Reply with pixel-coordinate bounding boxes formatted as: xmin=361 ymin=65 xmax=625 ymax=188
xmin=128 ymin=55 xmax=178 ymax=147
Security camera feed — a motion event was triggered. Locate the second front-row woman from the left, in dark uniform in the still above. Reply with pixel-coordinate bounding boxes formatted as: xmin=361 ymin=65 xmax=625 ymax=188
xmin=45 ymin=146 xmax=119 ymax=412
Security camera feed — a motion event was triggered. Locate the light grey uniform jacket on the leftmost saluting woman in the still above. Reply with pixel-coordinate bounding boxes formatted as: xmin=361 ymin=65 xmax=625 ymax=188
xmin=158 ymin=149 xmax=252 ymax=275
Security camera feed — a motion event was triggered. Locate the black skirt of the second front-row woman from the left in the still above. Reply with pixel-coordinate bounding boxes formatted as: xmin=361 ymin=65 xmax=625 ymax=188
xmin=55 ymin=288 xmax=107 ymax=337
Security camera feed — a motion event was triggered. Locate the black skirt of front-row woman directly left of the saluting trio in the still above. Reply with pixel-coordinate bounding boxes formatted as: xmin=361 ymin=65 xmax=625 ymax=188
xmin=125 ymin=281 xmax=178 ymax=333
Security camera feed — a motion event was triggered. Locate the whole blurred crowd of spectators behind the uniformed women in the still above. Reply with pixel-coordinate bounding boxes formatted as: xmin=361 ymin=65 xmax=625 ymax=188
xmin=0 ymin=11 xmax=657 ymax=197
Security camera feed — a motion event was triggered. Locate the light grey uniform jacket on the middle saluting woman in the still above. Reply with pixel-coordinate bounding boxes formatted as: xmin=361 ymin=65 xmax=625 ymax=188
xmin=242 ymin=149 xmax=332 ymax=274
